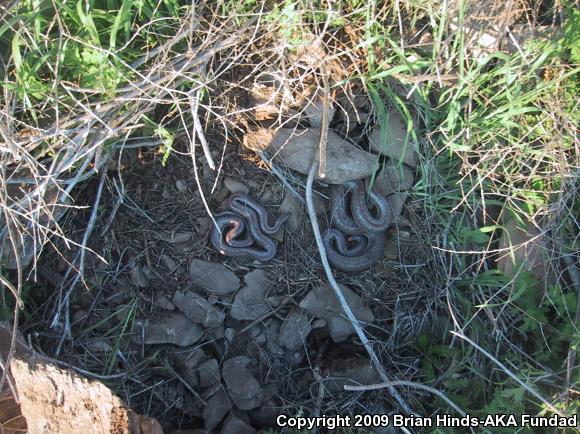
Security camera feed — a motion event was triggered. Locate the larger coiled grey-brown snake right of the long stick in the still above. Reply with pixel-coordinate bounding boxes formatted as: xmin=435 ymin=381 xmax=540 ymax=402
xmin=322 ymin=180 xmax=393 ymax=272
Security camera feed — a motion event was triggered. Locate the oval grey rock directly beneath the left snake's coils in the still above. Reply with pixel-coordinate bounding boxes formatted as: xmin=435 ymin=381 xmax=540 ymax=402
xmin=189 ymin=259 xmax=240 ymax=295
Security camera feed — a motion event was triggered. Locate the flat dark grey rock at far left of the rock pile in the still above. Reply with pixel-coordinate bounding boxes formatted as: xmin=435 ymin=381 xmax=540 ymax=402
xmin=143 ymin=312 xmax=203 ymax=347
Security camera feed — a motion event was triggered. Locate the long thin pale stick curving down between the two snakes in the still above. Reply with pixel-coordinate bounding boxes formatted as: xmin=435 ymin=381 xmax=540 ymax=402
xmin=306 ymin=159 xmax=412 ymax=414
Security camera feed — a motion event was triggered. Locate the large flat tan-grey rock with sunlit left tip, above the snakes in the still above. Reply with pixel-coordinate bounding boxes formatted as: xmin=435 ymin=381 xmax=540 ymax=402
xmin=244 ymin=128 xmax=376 ymax=184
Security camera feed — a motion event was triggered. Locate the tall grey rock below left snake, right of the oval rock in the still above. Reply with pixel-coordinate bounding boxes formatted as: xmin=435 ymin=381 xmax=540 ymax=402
xmin=230 ymin=269 xmax=270 ymax=320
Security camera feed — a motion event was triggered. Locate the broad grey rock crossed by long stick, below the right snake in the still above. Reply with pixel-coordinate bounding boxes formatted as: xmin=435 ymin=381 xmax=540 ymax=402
xmin=300 ymin=284 xmax=375 ymax=343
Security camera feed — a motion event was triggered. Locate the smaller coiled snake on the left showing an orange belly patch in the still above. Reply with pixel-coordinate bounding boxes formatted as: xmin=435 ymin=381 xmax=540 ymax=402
xmin=210 ymin=193 xmax=288 ymax=261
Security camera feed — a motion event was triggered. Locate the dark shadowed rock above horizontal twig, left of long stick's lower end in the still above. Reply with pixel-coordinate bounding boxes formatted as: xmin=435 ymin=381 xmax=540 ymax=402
xmin=326 ymin=358 xmax=381 ymax=393
